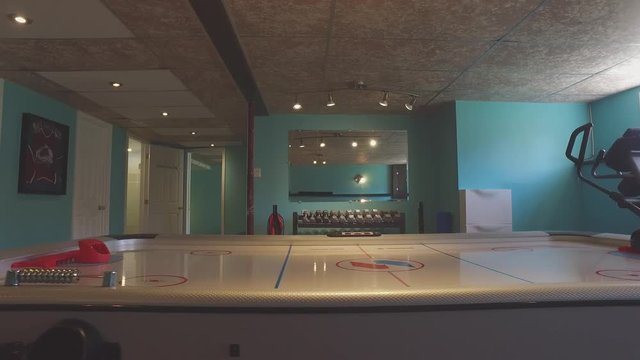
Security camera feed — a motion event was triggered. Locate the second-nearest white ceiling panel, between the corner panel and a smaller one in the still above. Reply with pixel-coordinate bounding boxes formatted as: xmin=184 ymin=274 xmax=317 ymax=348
xmin=38 ymin=70 xmax=186 ymax=92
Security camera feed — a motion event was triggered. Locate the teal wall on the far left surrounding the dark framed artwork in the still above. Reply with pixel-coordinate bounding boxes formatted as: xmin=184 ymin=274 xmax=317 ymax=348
xmin=0 ymin=81 xmax=76 ymax=248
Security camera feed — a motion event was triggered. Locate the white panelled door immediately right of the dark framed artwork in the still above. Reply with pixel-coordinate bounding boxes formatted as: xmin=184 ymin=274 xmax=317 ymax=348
xmin=72 ymin=112 xmax=112 ymax=239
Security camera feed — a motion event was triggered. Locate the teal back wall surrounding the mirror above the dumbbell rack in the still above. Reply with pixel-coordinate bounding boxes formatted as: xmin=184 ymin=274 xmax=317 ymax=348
xmin=254 ymin=115 xmax=424 ymax=234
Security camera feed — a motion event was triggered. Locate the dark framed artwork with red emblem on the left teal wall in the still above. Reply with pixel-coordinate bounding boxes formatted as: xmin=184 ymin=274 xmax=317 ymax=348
xmin=18 ymin=113 xmax=69 ymax=195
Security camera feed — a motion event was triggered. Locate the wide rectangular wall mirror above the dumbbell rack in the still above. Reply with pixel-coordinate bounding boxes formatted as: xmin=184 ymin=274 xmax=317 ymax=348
xmin=289 ymin=130 xmax=409 ymax=202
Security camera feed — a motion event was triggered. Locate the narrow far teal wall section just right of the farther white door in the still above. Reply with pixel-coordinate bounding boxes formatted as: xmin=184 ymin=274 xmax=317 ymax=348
xmin=190 ymin=164 xmax=222 ymax=234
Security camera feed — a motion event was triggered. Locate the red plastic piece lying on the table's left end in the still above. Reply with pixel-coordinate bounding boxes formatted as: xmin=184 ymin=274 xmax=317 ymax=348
xmin=11 ymin=239 xmax=111 ymax=269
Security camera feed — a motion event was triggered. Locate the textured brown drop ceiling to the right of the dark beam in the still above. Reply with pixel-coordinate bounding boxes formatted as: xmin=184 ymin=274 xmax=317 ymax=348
xmin=226 ymin=0 xmax=640 ymax=113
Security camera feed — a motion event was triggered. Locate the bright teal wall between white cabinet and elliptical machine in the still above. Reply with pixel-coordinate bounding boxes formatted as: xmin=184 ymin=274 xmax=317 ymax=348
xmin=456 ymin=101 xmax=589 ymax=231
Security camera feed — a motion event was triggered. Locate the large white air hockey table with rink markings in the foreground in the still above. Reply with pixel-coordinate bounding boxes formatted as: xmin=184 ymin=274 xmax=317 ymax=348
xmin=0 ymin=232 xmax=640 ymax=360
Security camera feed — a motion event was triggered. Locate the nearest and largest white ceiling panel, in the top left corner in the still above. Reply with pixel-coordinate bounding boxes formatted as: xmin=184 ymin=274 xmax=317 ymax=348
xmin=0 ymin=0 xmax=133 ymax=39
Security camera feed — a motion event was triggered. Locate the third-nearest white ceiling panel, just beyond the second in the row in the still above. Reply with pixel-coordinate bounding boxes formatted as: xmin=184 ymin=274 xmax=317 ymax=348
xmin=80 ymin=91 xmax=202 ymax=108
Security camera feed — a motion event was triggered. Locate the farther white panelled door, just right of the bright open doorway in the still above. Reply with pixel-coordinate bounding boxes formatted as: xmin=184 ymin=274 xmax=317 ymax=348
xmin=145 ymin=145 xmax=184 ymax=234
